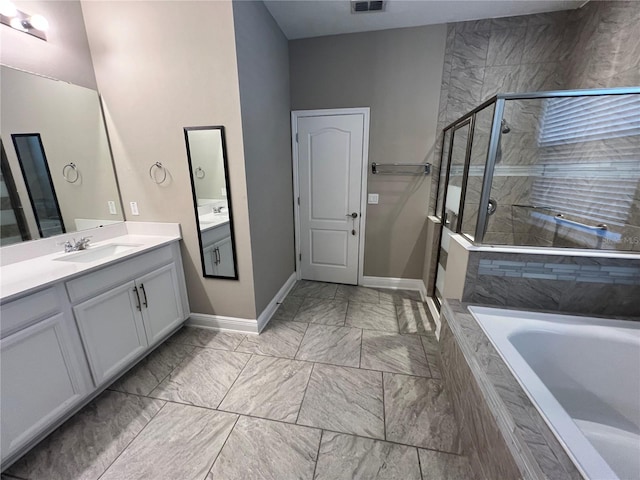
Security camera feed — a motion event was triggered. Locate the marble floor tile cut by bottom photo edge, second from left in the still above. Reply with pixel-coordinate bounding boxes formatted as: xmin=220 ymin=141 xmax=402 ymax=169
xmin=100 ymin=403 xmax=238 ymax=480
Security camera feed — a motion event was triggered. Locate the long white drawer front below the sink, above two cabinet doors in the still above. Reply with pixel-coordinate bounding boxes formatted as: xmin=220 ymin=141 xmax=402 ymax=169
xmin=67 ymin=245 xmax=173 ymax=303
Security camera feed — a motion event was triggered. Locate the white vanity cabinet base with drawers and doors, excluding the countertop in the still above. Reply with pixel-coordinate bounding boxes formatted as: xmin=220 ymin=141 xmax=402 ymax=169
xmin=0 ymin=241 xmax=189 ymax=469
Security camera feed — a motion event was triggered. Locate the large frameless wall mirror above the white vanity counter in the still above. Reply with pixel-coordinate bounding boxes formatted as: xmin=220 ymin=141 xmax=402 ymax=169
xmin=0 ymin=66 xmax=124 ymax=246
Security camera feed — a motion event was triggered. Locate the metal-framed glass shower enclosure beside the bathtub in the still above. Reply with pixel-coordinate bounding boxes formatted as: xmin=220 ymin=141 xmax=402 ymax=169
xmin=434 ymin=87 xmax=640 ymax=303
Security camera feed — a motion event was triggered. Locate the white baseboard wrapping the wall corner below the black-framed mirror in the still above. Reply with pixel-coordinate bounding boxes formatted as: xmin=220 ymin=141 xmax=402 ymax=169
xmin=186 ymin=272 xmax=296 ymax=334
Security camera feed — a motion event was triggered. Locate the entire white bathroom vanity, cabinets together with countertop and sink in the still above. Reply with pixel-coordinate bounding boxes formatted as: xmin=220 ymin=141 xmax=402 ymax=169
xmin=0 ymin=222 xmax=189 ymax=467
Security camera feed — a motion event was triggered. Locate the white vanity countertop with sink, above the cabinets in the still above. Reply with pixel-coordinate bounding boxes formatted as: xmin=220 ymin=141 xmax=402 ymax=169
xmin=0 ymin=222 xmax=182 ymax=303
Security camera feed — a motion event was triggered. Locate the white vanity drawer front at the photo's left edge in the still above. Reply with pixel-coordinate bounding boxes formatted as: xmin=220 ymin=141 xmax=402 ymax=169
xmin=0 ymin=288 xmax=59 ymax=337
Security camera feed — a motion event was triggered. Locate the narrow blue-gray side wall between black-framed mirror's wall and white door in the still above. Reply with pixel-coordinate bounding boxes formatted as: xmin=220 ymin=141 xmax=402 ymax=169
xmin=233 ymin=2 xmax=295 ymax=315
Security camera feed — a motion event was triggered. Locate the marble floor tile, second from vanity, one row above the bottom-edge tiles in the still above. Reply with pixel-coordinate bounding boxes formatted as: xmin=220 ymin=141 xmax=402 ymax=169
xmin=150 ymin=348 xmax=251 ymax=408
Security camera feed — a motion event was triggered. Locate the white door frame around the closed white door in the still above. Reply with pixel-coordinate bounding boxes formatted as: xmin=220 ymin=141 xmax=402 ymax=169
xmin=291 ymin=107 xmax=371 ymax=285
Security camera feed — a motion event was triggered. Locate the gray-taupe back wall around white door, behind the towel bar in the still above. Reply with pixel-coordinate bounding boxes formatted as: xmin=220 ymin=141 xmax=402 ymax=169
xmin=289 ymin=25 xmax=446 ymax=278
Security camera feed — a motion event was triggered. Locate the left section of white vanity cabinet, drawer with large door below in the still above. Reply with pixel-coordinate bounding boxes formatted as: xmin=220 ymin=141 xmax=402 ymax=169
xmin=0 ymin=286 xmax=93 ymax=459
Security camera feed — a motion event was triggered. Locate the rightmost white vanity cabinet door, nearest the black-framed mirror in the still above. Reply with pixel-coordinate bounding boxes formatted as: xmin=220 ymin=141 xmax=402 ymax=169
xmin=136 ymin=263 xmax=184 ymax=345
